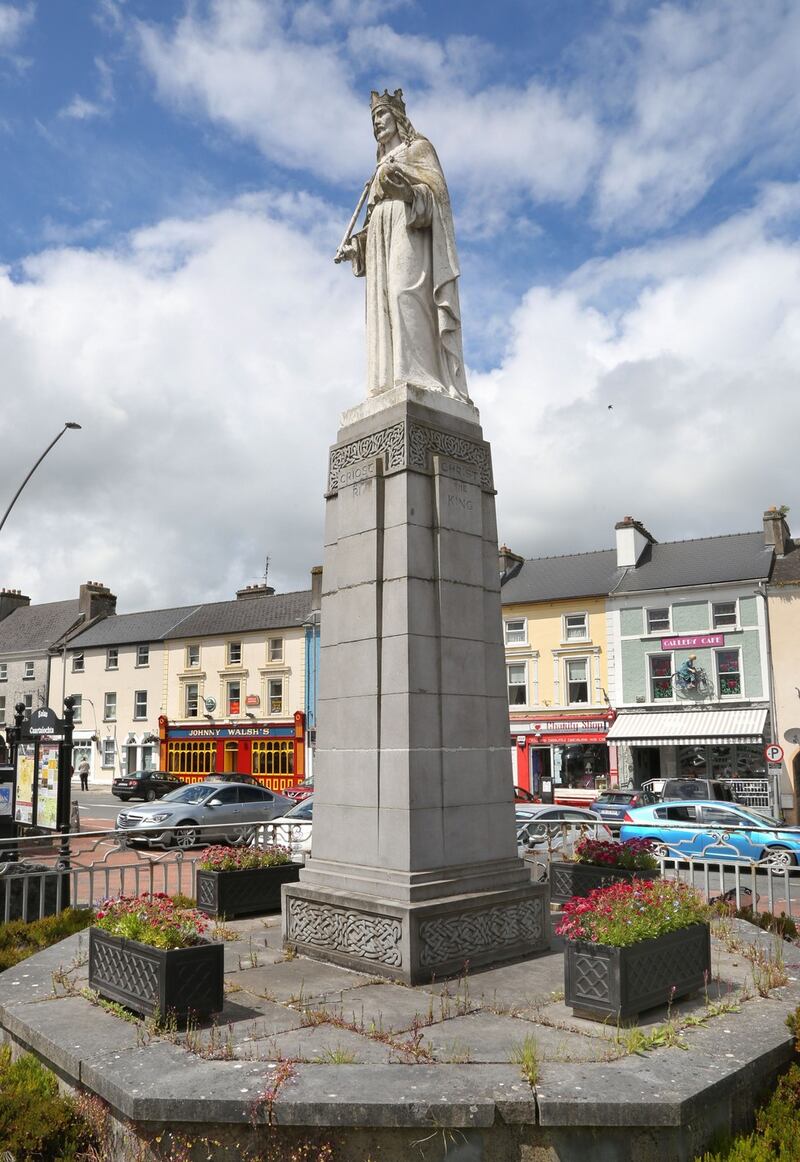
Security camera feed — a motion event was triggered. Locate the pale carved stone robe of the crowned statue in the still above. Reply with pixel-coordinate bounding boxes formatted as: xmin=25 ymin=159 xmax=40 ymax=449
xmin=352 ymin=137 xmax=469 ymax=401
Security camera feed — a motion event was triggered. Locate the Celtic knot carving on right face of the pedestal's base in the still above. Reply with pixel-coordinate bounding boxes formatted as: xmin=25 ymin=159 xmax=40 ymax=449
xmin=420 ymin=899 xmax=544 ymax=968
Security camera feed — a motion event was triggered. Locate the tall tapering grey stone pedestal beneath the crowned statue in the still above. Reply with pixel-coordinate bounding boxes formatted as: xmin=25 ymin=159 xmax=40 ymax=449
xmin=284 ymin=388 xmax=549 ymax=983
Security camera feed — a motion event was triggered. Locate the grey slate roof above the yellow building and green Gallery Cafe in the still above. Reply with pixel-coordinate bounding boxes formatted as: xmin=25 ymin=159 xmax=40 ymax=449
xmin=502 ymin=532 xmax=772 ymax=605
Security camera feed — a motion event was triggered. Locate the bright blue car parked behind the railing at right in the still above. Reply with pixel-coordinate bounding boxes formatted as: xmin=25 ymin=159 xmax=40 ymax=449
xmin=620 ymin=799 xmax=800 ymax=872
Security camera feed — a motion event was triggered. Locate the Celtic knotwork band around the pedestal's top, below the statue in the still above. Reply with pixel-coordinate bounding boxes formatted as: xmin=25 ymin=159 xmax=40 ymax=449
xmin=328 ymin=419 xmax=494 ymax=493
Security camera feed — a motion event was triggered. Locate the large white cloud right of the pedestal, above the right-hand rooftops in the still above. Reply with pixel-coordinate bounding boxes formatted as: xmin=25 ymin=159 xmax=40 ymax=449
xmin=472 ymin=187 xmax=800 ymax=555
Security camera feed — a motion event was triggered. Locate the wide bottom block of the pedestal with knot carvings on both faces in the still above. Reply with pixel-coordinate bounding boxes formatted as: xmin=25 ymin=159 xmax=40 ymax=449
xmin=283 ymin=883 xmax=550 ymax=984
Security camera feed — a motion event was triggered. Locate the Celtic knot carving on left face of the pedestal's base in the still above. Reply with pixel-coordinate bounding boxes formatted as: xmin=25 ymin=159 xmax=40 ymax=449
xmin=286 ymin=897 xmax=402 ymax=967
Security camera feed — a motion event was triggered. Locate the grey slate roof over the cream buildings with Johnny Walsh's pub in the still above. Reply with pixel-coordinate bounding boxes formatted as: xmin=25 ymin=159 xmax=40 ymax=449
xmin=67 ymin=589 xmax=312 ymax=650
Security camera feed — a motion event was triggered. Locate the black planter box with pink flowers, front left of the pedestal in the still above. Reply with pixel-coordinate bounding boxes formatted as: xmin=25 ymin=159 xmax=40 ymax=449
xmin=88 ymin=927 xmax=224 ymax=1019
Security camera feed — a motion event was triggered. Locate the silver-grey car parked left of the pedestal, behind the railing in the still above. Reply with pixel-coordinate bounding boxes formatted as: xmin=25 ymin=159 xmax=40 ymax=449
xmin=116 ymin=779 xmax=293 ymax=847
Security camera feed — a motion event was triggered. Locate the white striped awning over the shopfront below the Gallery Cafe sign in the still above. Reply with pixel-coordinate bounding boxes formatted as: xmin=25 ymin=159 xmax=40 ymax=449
xmin=608 ymin=706 xmax=766 ymax=746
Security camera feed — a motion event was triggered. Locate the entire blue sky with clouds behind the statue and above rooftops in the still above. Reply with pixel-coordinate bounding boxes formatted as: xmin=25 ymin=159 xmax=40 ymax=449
xmin=0 ymin=0 xmax=800 ymax=609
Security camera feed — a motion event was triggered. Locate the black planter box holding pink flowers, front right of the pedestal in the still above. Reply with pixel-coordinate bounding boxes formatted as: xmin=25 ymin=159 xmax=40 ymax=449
xmin=564 ymin=924 xmax=712 ymax=1021
